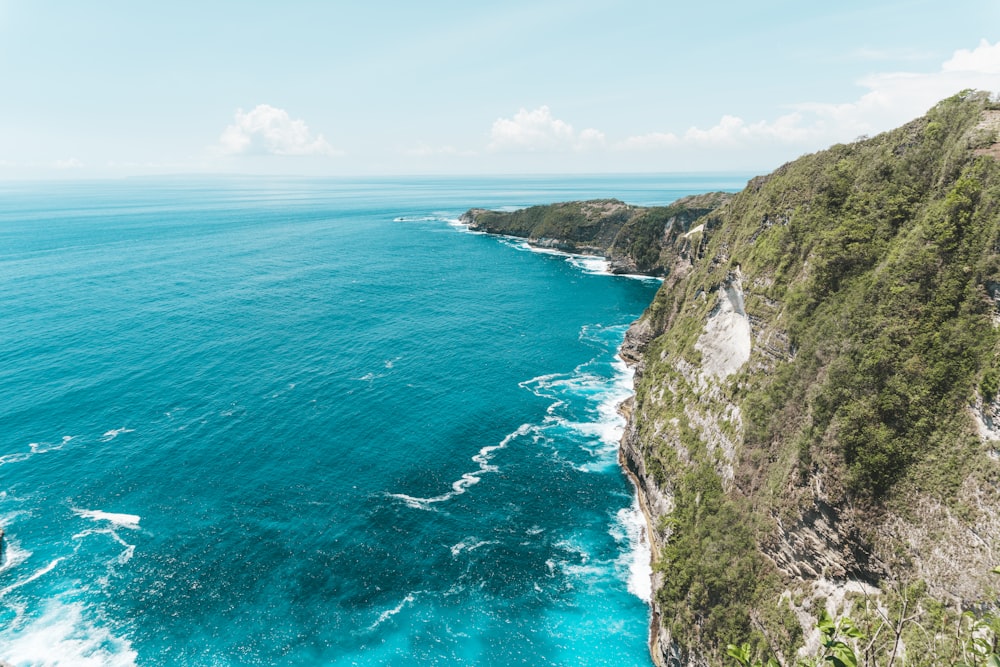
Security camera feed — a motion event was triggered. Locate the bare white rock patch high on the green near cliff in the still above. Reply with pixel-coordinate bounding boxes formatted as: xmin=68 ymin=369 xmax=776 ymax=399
xmin=694 ymin=270 xmax=750 ymax=380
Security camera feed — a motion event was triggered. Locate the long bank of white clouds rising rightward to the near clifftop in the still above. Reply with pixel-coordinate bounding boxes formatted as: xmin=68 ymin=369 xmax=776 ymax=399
xmin=480 ymin=39 xmax=1000 ymax=169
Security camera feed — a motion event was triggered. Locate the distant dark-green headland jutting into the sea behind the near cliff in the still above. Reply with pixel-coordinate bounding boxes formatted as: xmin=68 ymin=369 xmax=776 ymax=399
xmin=462 ymin=192 xmax=732 ymax=276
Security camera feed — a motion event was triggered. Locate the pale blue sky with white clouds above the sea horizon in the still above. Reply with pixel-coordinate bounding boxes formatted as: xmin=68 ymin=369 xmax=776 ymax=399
xmin=0 ymin=0 xmax=1000 ymax=180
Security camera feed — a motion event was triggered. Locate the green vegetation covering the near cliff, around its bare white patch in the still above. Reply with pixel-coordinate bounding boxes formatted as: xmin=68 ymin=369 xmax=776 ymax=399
xmin=636 ymin=94 xmax=1000 ymax=657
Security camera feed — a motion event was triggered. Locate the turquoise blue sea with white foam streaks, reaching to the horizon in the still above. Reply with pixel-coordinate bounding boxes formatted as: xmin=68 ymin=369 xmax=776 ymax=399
xmin=0 ymin=175 xmax=747 ymax=666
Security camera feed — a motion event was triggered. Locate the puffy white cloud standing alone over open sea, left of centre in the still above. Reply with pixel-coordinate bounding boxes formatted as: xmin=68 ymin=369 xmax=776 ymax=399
xmin=217 ymin=104 xmax=341 ymax=155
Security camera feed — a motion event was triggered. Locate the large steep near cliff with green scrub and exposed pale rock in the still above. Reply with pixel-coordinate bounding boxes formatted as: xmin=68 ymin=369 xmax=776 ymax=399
xmin=621 ymin=93 xmax=1000 ymax=665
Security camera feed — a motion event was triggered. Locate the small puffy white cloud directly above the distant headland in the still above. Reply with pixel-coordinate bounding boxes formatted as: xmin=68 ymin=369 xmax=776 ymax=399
xmin=489 ymin=106 xmax=604 ymax=152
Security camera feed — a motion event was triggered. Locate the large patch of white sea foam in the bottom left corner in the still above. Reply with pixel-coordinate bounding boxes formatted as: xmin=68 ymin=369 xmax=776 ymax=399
xmin=0 ymin=601 xmax=138 ymax=667
